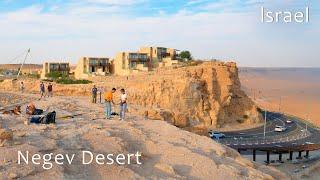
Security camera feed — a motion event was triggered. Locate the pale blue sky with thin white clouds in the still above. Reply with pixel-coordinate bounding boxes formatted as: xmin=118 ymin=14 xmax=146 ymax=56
xmin=0 ymin=0 xmax=320 ymax=67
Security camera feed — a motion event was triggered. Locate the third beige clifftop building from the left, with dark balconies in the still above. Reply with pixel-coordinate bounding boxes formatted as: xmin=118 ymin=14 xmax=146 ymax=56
xmin=113 ymin=52 xmax=150 ymax=75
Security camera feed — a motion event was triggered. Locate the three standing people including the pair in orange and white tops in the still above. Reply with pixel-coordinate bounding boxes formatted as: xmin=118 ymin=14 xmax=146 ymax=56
xmin=91 ymin=85 xmax=128 ymax=120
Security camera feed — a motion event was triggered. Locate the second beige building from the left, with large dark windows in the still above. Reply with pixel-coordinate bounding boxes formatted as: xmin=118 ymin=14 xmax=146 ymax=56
xmin=74 ymin=57 xmax=111 ymax=79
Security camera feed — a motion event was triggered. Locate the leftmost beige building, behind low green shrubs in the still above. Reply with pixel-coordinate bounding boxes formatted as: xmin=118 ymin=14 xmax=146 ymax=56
xmin=41 ymin=62 xmax=70 ymax=79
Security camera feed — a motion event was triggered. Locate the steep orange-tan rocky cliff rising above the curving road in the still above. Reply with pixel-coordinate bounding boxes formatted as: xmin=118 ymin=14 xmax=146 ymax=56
xmin=131 ymin=62 xmax=260 ymax=127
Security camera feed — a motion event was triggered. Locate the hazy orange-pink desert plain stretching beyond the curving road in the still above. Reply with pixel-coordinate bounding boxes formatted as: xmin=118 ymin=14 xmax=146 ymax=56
xmin=240 ymin=68 xmax=320 ymax=126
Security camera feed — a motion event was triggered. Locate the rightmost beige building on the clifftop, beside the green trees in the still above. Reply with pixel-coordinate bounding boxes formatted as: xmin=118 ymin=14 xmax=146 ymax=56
xmin=139 ymin=47 xmax=178 ymax=68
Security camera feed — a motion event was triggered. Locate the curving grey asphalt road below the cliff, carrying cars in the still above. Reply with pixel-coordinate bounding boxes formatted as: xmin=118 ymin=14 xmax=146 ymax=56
xmin=217 ymin=112 xmax=320 ymax=150
